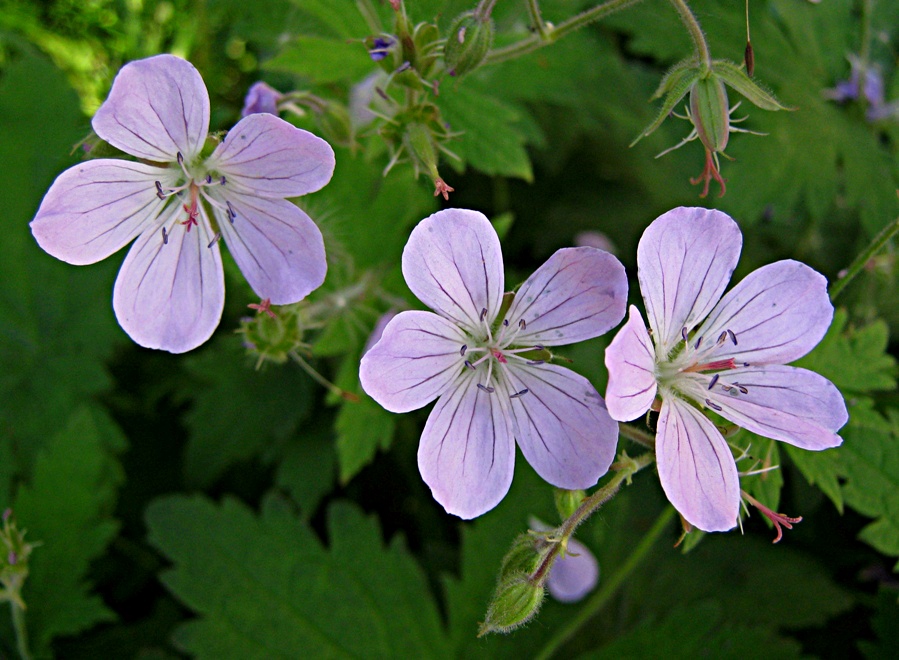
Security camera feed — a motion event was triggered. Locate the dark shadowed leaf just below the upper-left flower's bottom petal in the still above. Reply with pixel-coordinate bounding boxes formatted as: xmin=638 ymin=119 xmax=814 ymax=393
xmin=179 ymin=336 xmax=314 ymax=487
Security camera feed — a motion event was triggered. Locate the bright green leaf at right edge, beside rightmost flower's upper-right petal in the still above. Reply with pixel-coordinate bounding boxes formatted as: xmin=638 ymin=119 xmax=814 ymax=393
xmin=796 ymin=309 xmax=896 ymax=392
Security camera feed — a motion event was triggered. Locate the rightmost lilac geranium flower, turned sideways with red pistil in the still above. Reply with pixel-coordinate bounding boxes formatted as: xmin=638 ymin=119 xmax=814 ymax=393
xmin=606 ymin=208 xmax=848 ymax=532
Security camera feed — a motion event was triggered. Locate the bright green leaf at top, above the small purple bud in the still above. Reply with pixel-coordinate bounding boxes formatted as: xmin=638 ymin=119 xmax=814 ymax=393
xmin=263 ymin=36 xmax=374 ymax=84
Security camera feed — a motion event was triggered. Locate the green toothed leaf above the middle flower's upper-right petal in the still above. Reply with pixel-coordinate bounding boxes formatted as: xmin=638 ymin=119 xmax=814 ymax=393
xmin=437 ymin=79 xmax=542 ymax=181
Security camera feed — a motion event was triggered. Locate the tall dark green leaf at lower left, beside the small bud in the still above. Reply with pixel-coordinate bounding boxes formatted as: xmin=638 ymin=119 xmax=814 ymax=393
xmin=14 ymin=408 xmax=125 ymax=656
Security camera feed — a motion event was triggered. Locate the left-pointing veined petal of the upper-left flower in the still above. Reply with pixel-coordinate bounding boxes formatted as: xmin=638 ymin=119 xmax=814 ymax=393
xmin=31 ymin=159 xmax=176 ymax=266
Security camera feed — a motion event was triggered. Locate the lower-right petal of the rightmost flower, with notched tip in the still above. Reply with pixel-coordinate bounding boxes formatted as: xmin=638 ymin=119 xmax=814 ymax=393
xmin=705 ymin=365 xmax=849 ymax=450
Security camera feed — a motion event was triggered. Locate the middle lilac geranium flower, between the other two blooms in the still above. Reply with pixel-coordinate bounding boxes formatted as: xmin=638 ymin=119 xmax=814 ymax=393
xmin=359 ymin=209 xmax=627 ymax=518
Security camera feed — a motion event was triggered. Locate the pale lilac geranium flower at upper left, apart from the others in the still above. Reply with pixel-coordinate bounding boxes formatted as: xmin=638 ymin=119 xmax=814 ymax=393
xmin=31 ymin=55 xmax=334 ymax=353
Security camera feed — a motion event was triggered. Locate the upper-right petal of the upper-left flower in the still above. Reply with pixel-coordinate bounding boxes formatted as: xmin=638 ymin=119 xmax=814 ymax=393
xmin=206 ymin=114 xmax=334 ymax=197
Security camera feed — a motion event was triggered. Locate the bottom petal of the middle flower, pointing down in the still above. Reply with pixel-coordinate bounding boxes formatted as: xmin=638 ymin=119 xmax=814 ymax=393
xmin=420 ymin=372 xmax=515 ymax=519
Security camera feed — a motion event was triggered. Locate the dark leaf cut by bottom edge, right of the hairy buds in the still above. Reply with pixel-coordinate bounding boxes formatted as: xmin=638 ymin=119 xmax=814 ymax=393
xmin=580 ymin=601 xmax=802 ymax=660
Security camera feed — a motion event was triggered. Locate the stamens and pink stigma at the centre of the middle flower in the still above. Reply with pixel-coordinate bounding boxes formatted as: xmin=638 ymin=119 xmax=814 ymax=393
xmin=459 ymin=309 xmax=545 ymax=399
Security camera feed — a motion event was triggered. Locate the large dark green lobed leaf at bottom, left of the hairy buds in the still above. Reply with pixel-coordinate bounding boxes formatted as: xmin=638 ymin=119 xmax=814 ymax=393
xmin=146 ymin=495 xmax=458 ymax=658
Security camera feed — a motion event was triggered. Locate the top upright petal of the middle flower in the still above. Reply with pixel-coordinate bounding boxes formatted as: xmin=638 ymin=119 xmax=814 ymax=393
xmin=403 ymin=209 xmax=503 ymax=331
